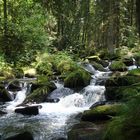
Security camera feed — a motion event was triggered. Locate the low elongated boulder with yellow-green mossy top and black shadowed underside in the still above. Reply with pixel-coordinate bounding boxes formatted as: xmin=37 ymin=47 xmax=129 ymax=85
xmin=81 ymin=104 xmax=121 ymax=122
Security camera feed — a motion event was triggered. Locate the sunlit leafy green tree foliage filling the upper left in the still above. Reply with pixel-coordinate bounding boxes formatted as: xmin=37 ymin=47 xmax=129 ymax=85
xmin=0 ymin=0 xmax=55 ymax=65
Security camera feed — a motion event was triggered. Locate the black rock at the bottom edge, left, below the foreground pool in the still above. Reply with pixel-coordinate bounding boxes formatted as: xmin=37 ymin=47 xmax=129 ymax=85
xmin=5 ymin=132 xmax=34 ymax=140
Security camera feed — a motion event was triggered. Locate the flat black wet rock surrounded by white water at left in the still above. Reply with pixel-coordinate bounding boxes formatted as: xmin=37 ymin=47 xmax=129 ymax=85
xmin=15 ymin=105 xmax=41 ymax=115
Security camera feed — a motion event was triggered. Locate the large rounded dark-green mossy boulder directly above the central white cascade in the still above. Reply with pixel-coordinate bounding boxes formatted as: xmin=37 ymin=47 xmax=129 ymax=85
xmin=64 ymin=68 xmax=91 ymax=88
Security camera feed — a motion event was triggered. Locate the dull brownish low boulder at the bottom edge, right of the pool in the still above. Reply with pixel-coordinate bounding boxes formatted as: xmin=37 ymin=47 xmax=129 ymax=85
xmin=68 ymin=122 xmax=106 ymax=140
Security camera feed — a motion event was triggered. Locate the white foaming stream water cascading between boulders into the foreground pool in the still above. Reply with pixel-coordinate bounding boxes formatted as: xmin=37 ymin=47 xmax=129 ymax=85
xmin=0 ymin=65 xmax=110 ymax=140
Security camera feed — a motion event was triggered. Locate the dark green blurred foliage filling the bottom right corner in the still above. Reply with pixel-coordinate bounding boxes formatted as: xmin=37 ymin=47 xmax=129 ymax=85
xmin=105 ymin=96 xmax=140 ymax=140
